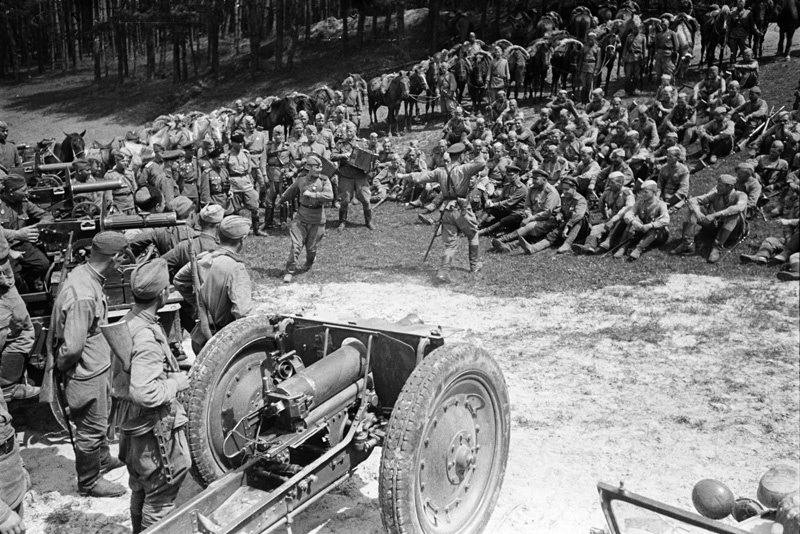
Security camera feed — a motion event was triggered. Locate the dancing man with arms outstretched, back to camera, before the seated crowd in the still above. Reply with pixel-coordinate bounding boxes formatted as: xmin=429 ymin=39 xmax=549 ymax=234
xmin=397 ymin=143 xmax=486 ymax=283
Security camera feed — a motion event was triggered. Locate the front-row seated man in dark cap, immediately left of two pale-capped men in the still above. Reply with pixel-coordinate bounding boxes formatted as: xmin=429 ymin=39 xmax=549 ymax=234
xmin=517 ymin=176 xmax=589 ymax=254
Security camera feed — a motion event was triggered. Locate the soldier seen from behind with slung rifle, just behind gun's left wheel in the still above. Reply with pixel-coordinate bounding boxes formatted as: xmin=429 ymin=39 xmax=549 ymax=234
xmin=173 ymin=215 xmax=253 ymax=354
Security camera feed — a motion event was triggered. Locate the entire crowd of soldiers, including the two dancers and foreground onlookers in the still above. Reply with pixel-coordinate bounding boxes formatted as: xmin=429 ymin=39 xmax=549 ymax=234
xmin=0 ymin=19 xmax=800 ymax=532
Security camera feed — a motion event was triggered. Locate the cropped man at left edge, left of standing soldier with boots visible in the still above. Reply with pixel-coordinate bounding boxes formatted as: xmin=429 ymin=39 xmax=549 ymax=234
xmin=0 ymin=233 xmax=39 ymax=404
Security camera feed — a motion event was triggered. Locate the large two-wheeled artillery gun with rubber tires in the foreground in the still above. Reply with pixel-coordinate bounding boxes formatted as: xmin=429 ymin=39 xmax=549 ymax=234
xmin=148 ymin=315 xmax=510 ymax=534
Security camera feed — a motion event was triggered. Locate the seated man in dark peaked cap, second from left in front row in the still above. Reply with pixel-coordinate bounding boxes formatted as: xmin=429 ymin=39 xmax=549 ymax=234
xmin=492 ymin=169 xmax=561 ymax=252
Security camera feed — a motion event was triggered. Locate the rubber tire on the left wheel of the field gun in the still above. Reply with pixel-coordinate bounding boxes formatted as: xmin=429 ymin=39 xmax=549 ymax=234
xmin=183 ymin=315 xmax=273 ymax=487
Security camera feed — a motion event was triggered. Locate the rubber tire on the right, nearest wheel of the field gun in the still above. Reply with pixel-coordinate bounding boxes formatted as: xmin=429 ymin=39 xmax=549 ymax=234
xmin=379 ymin=344 xmax=511 ymax=534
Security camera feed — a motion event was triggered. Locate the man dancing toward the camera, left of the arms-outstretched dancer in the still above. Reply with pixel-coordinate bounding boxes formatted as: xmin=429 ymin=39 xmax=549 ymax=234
xmin=280 ymin=154 xmax=333 ymax=284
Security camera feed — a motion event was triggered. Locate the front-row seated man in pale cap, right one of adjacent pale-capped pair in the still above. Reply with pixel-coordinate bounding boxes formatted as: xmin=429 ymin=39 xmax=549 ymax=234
xmin=614 ymin=180 xmax=669 ymax=261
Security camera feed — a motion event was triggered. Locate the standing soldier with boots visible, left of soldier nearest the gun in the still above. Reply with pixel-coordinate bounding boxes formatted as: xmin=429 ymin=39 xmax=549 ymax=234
xmin=42 ymin=232 xmax=128 ymax=497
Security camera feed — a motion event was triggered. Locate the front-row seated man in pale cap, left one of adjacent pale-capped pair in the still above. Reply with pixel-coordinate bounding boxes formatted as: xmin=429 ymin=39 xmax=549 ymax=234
xmin=572 ymin=171 xmax=636 ymax=254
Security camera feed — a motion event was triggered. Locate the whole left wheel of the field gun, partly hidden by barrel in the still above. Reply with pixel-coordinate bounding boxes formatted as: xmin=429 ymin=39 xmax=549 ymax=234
xmin=183 ymin=316 xmax=275 ymax=487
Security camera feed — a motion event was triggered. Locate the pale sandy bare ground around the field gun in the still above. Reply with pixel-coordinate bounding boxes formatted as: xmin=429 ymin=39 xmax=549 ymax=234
xmin=14 ymin=276 xmax=800 ymax=534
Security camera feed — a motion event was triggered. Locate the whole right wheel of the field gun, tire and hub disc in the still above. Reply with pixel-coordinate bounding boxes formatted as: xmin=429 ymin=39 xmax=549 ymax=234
xmin=379 ymin=344 xmax=511 ymax=534
